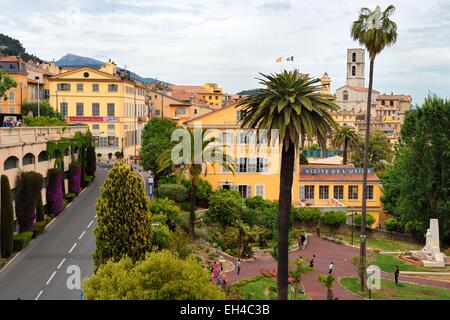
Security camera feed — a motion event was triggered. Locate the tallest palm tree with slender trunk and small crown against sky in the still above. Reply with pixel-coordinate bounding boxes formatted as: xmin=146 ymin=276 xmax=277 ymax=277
xmin=351 ymin=5 xmax=397 ymax=291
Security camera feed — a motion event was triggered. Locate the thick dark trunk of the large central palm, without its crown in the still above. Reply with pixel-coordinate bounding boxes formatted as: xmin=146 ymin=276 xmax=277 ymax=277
xmin=277 ymin=139 xmax=295 ymax=300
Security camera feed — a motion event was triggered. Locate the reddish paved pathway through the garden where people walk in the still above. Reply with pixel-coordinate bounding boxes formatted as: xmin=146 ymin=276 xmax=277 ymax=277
xmin=228 ymin=236 xmax=450 ymax=300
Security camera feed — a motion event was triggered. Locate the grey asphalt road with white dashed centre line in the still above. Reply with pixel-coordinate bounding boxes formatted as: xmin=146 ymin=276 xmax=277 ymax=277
xmin=0 ymin=166 xmax=108 ymax=300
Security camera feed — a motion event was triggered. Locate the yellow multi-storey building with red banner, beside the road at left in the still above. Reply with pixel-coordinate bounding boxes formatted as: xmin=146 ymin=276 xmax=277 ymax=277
xmin=48 ymin=61 xmax=149 ymax=161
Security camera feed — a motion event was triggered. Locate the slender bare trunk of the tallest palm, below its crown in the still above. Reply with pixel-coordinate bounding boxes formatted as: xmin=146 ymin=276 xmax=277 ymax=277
xmin=359 ymin=58 xmax=375 ymax=291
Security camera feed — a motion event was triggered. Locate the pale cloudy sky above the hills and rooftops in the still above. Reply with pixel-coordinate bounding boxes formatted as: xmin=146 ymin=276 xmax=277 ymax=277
xmin=0 ymin=0 xmax=450 ymax=104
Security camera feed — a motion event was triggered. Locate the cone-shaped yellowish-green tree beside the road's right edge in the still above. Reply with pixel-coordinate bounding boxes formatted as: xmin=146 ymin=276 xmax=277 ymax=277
xmin=93 ymin=161 xmax=151 ymax=268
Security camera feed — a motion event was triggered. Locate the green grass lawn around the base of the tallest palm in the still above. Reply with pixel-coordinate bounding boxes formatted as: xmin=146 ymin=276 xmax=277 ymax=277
xmin=340 ymin=277 xmax=450 ymax=300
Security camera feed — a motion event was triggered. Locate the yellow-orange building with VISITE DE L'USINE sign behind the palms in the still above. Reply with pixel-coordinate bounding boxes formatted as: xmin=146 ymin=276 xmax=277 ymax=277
xmin=185 ymin=105 xmax=383 ymax=226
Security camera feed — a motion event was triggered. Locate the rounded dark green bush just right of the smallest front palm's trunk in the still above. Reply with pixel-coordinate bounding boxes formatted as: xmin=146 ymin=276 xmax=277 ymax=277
xmin=205 ymin=190 xmax=244 ymax=228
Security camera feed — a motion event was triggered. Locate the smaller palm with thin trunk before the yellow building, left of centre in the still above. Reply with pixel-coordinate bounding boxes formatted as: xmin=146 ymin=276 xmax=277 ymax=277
xmin=158 ymin=129 xmax=234 ymax=241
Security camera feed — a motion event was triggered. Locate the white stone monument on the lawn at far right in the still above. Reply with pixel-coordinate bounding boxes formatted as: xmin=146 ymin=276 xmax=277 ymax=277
xmin=421 ymin=219 xmax=445 ymax=268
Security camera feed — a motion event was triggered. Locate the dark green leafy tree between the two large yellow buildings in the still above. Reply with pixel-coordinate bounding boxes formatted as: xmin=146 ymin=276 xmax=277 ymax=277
xmin=141 ymin=118 xmax=177 ymax=182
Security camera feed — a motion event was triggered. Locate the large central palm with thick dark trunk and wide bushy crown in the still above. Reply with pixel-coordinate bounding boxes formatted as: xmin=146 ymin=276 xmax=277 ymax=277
xmin=236 ymin=70 xmax=338 ymax=300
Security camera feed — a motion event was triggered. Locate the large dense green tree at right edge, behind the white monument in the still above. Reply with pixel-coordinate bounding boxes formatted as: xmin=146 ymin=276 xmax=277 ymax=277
xmin=382 ymin=95 xmax=450 ymax=244
